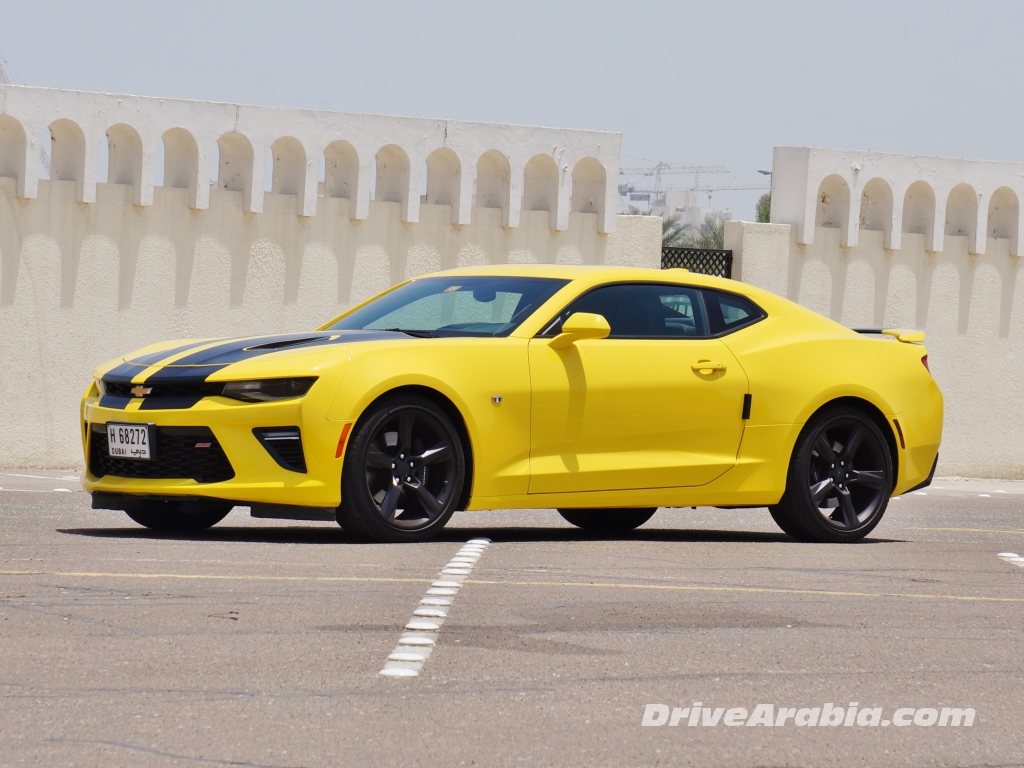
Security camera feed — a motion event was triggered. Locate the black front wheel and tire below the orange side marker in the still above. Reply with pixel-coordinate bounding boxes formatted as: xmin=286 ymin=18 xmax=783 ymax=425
xmin=338 ymin=394 xmax=466 ymax=542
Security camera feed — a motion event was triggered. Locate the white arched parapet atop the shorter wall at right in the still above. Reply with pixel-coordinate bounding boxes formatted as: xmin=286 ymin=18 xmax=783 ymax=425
xmin=771 ymin=146 xmax=1024 ymax=256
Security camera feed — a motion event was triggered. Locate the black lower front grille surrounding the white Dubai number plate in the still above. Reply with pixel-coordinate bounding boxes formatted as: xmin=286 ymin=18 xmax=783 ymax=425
xmin=89 ymin=424 xmax=234 ymax=482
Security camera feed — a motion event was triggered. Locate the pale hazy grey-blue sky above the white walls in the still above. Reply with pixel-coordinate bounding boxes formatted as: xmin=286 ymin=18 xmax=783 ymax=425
xmin=0 ymin=0 xmax=1024 ymax=219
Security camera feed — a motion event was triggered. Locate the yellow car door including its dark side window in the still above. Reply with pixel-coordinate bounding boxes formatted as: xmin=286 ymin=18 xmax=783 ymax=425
xmin=529 ymin=283 xmax=748 ymax=494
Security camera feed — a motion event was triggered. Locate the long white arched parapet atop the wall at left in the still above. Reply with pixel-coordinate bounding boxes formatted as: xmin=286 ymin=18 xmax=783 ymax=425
xmin=0 ymin=85 xmax=622 ymax=232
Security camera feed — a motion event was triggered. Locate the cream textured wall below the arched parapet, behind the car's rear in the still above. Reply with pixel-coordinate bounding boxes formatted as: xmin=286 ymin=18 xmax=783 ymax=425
xmin=725 ymin=219 xmax=1024 ymax=479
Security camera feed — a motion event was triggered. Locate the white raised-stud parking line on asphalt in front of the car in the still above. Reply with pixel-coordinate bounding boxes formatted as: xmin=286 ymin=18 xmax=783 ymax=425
xmin=378 ymin=539 xmax=490 ymax=677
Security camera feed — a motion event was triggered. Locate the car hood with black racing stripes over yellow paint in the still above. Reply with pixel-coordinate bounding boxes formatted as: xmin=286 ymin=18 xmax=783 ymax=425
xmin=102 ymin=331 xmax=409 ymax=383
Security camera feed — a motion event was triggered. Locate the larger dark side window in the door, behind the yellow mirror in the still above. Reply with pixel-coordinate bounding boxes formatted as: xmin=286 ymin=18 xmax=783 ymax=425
xmin=540 ymin=283 xmax=708 ymax=339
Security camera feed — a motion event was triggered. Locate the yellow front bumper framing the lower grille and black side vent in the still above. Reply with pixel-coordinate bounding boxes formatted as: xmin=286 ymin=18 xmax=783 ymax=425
xmin=82 ymin=393 xmax=344 ymax=507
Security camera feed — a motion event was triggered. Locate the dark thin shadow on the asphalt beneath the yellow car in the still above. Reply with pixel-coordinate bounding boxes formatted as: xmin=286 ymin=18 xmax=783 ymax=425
xmin=56 ymin=525 xmax=902 ymax=545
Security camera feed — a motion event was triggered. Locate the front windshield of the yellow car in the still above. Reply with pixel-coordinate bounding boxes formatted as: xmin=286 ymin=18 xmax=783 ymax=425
xmin=329 ymin=276 xmax=568 ymax=336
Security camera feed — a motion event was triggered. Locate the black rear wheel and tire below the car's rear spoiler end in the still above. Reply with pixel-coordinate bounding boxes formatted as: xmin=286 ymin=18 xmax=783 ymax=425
xmin=769 ymin=406 xmax=893 ymax=544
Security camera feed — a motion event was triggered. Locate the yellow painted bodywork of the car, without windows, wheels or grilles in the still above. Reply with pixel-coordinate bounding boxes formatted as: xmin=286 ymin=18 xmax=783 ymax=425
xmin=81 ymin=265 xmax=942 ymax=509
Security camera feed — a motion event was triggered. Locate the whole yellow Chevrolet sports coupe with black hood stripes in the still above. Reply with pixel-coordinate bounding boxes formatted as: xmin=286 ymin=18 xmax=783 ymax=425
xmin=82 ymin=265 xmax=942 ymax=542
